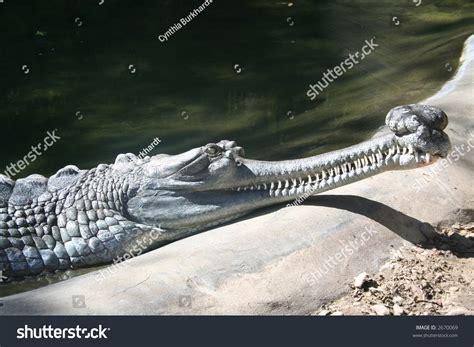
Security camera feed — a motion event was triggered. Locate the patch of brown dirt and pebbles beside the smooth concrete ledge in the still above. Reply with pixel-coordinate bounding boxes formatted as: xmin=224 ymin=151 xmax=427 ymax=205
xmin=315 ymin=222 xmax=474 ymax=316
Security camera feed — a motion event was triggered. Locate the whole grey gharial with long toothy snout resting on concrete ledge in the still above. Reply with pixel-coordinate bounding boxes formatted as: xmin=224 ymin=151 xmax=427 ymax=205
xmin=0 ymin=105 xmax=450 ymax=278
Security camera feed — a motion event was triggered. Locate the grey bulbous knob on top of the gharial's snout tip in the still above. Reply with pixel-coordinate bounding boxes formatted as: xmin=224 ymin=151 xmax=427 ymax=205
xmin=385 ymin=104 xmax=448 ymax=135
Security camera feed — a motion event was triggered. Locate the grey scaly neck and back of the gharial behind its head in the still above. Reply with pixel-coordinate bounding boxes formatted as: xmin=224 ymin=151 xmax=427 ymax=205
xmin=0 ymin=165 xmax=165 ymax=276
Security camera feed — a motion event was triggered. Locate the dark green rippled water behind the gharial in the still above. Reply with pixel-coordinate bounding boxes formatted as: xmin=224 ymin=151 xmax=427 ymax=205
xmin=0 ymin=0 xmax=473 ymax=178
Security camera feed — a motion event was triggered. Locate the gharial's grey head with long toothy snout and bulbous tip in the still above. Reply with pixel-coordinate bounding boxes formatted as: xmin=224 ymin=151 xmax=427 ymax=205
xmin=127 ymin=105 xmax=450 ymax=230
